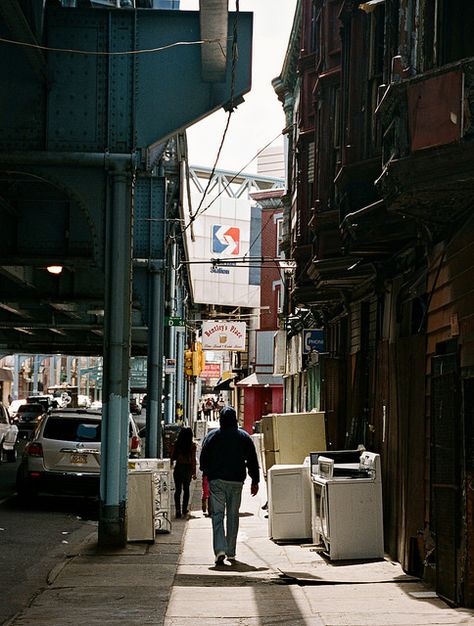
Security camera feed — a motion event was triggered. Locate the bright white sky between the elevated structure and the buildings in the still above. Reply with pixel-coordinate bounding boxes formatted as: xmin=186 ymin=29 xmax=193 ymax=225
xmin=180 ymin=0 xmax=296 ymax=173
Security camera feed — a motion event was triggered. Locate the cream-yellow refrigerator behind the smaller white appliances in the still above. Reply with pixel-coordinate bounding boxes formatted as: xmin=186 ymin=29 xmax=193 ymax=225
xmin=262 ymin=412 xmax=327 ymax=472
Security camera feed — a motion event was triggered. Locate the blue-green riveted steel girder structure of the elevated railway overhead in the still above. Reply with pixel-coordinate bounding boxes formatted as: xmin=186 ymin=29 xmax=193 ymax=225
xmin=0 ymin=2 xmax=251 ymax=354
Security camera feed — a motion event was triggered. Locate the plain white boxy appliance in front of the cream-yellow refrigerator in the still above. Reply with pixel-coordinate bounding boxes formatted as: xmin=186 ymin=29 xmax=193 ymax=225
xmin=268 ymin=464 xmax=312 ymax=540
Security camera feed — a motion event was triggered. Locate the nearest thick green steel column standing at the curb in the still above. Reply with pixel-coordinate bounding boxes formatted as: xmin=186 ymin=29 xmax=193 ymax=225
xmin=98 ymin=169 xmax=132 ymax=546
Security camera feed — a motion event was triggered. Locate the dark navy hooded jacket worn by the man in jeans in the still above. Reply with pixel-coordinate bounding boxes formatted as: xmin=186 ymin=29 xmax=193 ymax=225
xmin=200 ymin=406 xmax=260 ymax=485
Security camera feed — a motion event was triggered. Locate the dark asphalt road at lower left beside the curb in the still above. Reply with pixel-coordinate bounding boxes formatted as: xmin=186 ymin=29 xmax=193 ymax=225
xmin=0 ymin=448 xmax=98 ymax=624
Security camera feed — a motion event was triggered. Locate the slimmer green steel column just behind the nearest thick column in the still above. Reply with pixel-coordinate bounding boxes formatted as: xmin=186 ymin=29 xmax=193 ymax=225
xmin=145 ymin=261 xmax=164 ymax=458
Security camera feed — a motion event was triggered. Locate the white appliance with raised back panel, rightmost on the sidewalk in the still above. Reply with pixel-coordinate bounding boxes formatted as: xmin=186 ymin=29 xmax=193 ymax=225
xmin=310 ymin=450 xmax=384 ymax=560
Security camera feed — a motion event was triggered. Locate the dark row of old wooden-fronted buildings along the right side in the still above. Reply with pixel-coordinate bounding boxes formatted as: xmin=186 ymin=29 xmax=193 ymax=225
xmin=273 ymin=0 xmax=474 ymax=606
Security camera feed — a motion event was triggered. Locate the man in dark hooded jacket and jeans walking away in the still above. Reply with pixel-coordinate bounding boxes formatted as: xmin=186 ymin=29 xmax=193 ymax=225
xmin=200 ymin=406 xmax=260 ymax=565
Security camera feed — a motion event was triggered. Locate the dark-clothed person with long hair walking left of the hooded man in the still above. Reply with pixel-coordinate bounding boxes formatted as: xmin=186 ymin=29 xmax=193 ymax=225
xmin=171 ymin=427 xmax=196 ymax=517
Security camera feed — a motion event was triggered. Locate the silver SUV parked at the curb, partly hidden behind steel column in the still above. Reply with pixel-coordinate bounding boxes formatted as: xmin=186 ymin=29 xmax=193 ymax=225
xmin=16 ymin=409 xmax=141 ymax=497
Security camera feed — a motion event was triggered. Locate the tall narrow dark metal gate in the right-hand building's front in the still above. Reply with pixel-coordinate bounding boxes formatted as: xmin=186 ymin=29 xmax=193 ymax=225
xmin=431 ymin=352 xmax=463 ymax=604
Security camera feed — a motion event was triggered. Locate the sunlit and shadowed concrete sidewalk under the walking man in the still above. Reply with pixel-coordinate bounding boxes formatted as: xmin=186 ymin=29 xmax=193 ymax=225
xmin=9 ymin=483 xmax=474 ymax=626
